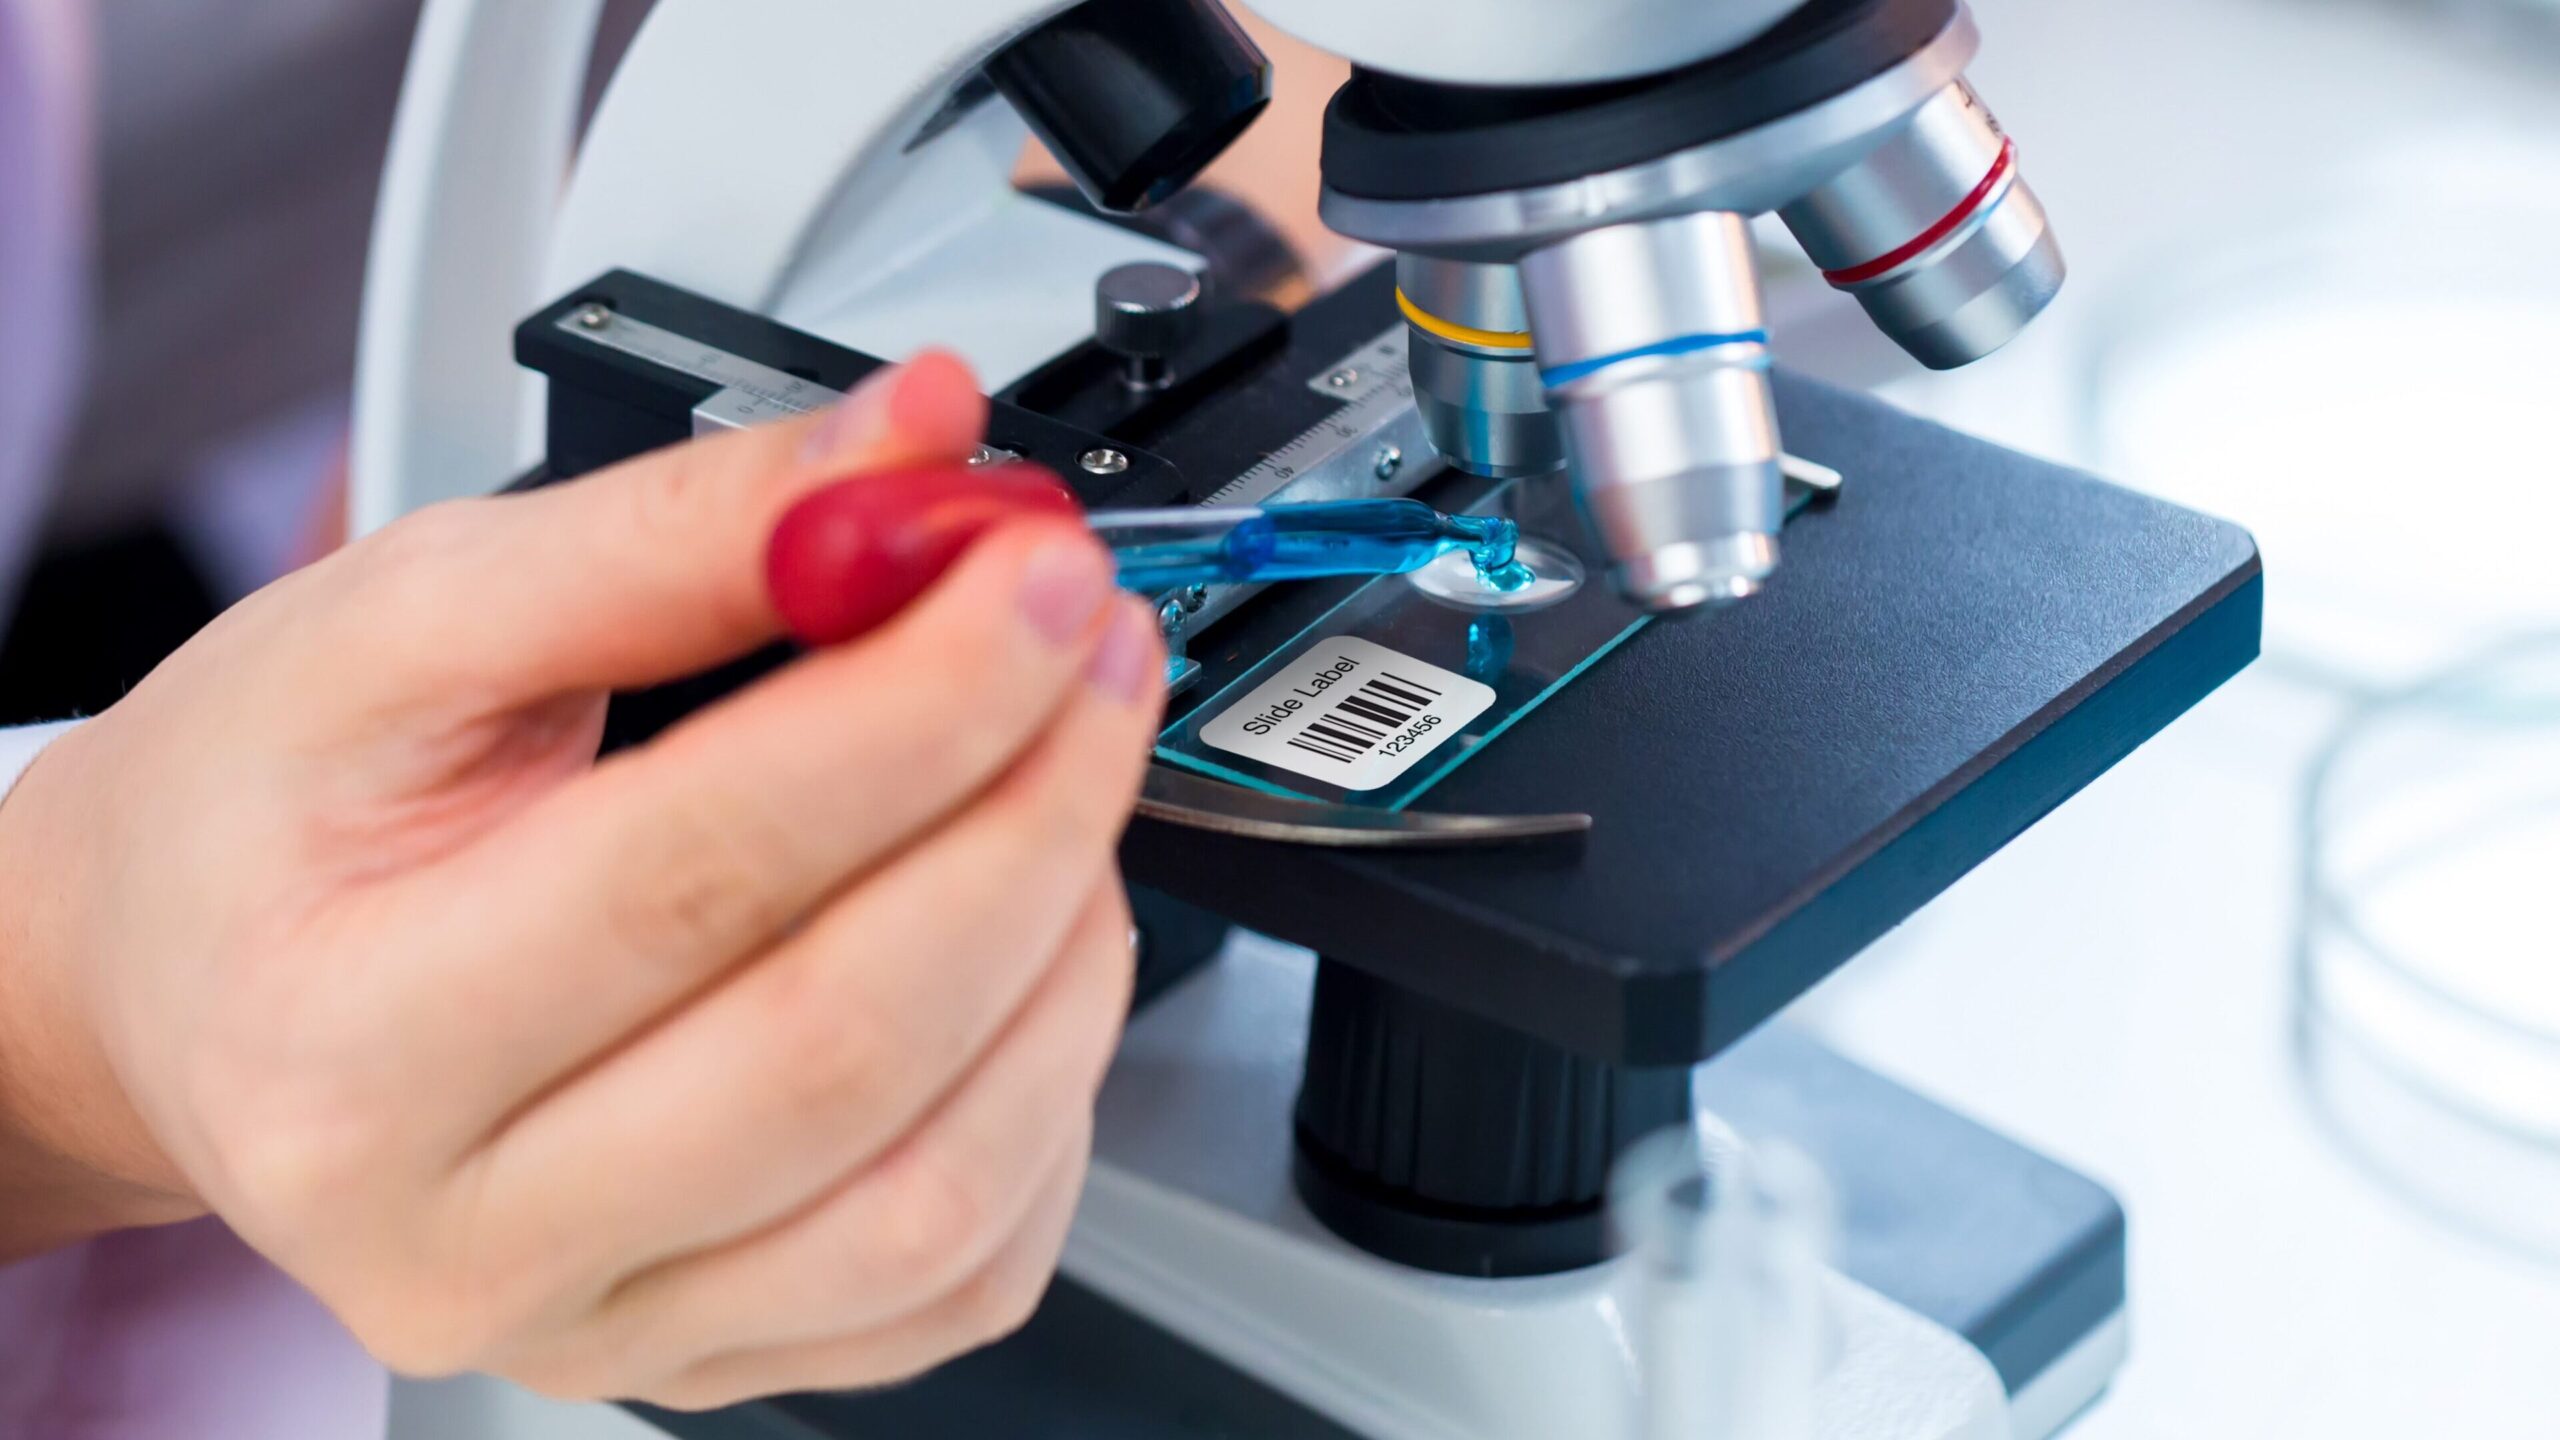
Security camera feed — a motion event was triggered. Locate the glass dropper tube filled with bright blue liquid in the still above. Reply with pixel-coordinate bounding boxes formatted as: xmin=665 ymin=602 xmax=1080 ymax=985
xmin=1093 ymin=500 xmax=1536 ymax=594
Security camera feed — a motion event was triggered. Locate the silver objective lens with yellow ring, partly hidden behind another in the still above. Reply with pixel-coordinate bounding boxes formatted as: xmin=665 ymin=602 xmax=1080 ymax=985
xmin=1395 ymin=254 xmax=1564 ymax=479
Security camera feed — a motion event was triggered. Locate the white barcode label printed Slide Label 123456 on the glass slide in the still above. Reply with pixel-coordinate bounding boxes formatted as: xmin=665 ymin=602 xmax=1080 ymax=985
xmin=1201 ymin=635 xmax=1492 ymax=789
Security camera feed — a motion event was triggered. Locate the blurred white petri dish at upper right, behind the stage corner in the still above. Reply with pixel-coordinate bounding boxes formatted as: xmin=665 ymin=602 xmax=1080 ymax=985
xmin=2081 ymin=133 xmax=2560 ymax=687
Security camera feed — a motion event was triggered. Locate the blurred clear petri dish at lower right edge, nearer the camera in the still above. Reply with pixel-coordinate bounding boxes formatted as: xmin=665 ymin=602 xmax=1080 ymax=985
xmin=2294 ymin=633 xmax=2560 ymax=1263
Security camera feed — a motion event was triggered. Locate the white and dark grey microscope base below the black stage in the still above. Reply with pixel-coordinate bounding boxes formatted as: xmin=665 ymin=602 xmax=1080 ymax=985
xmin=634 ymin=938 xmax=2125 ymax=1440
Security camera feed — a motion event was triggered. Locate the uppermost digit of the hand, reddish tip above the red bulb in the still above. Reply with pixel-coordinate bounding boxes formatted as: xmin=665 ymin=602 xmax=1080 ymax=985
xmin=351 ymin=351 xmax=986 ymax=702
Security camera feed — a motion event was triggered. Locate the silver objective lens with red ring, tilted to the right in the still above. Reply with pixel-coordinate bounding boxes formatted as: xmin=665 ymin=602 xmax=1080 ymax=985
xmin=1779 ymin=82 xmax=2063 ymax=369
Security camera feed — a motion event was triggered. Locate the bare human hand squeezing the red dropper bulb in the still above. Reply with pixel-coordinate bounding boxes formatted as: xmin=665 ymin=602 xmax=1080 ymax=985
xmin=0 ymin=359 xmax=1162 ymax=1407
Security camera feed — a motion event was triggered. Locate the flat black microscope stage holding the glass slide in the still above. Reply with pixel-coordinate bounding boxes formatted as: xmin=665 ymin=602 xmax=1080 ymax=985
xmin=1124 ymin=374 xmax=2260 ymax=1066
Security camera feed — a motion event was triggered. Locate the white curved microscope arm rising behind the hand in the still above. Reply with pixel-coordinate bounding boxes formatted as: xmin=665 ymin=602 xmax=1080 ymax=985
xmin=353 ymin=0 xmax=1116 ymax=530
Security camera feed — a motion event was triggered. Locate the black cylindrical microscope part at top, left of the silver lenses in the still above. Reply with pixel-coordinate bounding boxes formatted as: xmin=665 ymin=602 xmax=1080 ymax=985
xmin=986 ymin=0 xmax=1272 ymax=215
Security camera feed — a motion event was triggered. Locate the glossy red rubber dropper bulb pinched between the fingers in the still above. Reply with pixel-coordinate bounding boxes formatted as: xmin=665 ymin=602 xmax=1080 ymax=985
xmin=765 ymin=464 xmax=1085 ymax=646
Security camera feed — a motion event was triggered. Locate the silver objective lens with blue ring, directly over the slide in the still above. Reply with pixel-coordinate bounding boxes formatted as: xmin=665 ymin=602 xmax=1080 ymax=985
xmin=1521 ymin=210 xmax=1784 ymax=612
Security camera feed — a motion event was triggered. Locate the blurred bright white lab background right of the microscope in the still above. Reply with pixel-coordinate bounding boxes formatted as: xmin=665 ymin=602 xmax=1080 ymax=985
xmin=1782 ymin=0 xmax=2560 ymax=1440
